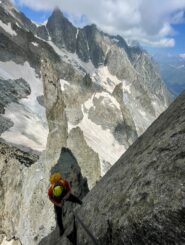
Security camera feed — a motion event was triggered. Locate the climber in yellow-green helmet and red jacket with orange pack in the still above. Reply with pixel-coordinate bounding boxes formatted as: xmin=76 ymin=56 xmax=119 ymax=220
xmin=48 ymin=172 xmax=82 ymax=236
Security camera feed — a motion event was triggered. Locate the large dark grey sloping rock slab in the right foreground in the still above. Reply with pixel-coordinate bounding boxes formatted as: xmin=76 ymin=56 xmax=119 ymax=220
xmin=77 ymin=93 xmax=185 ymax=245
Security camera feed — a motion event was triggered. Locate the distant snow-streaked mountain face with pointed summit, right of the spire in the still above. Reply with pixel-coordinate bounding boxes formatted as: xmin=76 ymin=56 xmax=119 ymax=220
xmin=43 ymin=9 xmax=172 ymax=179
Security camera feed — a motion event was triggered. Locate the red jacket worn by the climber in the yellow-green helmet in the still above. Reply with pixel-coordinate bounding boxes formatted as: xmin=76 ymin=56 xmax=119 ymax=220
xmin=48 ymin=179 xmax=71 ymax=204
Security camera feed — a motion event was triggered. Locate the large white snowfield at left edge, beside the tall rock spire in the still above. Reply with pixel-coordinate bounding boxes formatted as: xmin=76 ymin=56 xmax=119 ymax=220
xmin=0 ymin=61 xmax=48 ymax=151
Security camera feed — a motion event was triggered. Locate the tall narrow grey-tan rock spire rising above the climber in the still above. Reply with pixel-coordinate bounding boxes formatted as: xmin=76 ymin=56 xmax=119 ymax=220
xmin=41 ymin=57 xmax=67 ymax=161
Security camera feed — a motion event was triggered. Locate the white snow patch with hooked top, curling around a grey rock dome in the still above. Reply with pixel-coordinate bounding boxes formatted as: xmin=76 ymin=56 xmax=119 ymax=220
xmin=68 ymin=93 xmax=126 ymax=176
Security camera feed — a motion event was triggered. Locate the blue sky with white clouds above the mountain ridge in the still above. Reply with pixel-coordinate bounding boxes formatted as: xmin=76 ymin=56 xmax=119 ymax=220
xmin=12 ymin=0 xmax=185 ymax=54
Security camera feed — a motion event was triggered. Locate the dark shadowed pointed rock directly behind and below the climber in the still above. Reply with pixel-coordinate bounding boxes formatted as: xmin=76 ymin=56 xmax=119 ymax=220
xmin=38 ymin=148 xmax=89 ymax=245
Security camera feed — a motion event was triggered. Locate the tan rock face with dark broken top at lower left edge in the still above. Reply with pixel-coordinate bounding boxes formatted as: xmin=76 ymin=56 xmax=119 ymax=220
xmin=0 ymin=143 xmax=38 ymax=242
